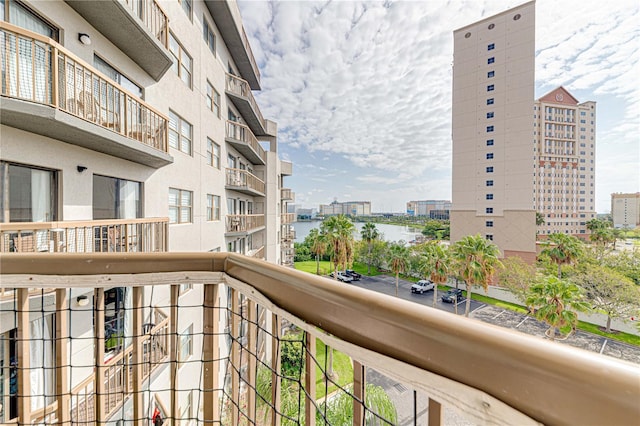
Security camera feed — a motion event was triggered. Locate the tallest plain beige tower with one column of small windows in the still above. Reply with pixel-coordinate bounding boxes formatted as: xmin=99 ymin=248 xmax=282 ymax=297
xmin=451 ymin=2 xmax=536 ymax=261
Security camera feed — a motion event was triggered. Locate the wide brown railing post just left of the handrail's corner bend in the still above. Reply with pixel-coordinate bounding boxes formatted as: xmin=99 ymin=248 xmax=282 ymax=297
xmin=202 ymin=284 xmax=220 ymax=424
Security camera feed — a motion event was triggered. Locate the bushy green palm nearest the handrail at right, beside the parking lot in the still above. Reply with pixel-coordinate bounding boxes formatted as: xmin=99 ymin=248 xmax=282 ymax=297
xmin=527 ymin=276 xmax=589 ymax=340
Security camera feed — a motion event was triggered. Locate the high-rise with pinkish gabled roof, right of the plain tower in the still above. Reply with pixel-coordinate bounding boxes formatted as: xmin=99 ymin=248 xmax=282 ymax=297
xmin=533 ymin=87 xmax=596 ymax=239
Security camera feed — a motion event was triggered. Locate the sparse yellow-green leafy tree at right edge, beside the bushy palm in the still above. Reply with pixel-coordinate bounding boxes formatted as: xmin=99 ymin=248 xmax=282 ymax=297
xmin=571 ymin=265 xmax=640 ymax=333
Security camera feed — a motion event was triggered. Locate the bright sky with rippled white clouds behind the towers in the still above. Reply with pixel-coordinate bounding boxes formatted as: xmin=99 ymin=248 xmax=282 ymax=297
xmin=239 ymin=0 xmax=640 ymax=212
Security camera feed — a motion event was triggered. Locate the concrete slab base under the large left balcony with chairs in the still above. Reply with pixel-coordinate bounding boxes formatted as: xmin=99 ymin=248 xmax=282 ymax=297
xmin=0 ymin=97 xmax=173 ymax=169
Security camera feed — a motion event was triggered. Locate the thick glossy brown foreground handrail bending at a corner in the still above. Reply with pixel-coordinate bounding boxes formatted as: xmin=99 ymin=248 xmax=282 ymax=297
xmin=0 ymin=253 xmax=640 ymax=424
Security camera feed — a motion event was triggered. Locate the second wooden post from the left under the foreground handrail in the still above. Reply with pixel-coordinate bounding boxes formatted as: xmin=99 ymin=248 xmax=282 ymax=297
xmin=55 ymin=288 xmax=71 ymax=425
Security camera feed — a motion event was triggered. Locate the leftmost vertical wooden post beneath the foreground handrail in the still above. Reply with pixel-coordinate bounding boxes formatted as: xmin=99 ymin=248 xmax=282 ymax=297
xmin=16 ymin=288 xmax=31 ymax=425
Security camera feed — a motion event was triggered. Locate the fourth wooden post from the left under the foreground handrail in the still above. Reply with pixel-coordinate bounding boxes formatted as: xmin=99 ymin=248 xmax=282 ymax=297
xmin=131 ymin=287 xmax=144 ymax=426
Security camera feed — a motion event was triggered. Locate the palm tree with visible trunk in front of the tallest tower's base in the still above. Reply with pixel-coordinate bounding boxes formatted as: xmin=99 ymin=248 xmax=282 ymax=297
xmin=452 ymin=234 xmax=502 ymax=317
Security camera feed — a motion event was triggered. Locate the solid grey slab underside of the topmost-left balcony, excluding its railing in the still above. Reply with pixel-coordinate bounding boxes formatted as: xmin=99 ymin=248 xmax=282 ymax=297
xmin=65 ymin=0 xmax=173 ymax=81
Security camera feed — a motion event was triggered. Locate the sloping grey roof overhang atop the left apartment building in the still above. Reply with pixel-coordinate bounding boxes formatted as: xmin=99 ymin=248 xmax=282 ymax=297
xmin=204 ymin=0 xmax=260 ymax=90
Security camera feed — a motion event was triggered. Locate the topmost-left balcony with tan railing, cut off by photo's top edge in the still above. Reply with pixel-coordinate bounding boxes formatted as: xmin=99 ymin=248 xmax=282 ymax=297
xmin=65 ymin=0 xmax=173 ymax=81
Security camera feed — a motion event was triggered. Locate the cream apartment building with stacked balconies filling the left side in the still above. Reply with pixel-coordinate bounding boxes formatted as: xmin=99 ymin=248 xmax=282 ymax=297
xmin=0 ymin=0 xmax=295 ymax=422
